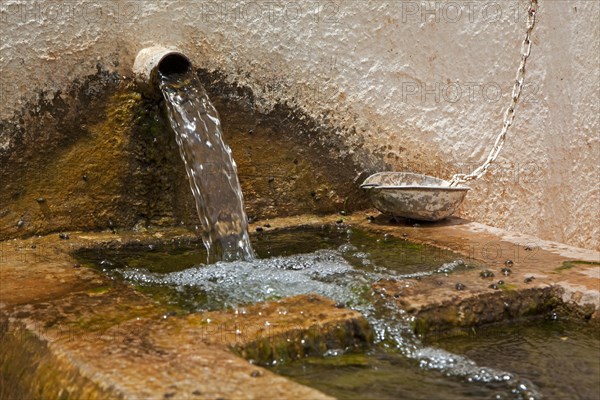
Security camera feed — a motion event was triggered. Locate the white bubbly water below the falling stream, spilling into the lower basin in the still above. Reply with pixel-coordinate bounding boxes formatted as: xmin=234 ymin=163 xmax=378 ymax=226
xmin=116 ymin=245 xmax=542 ymax=400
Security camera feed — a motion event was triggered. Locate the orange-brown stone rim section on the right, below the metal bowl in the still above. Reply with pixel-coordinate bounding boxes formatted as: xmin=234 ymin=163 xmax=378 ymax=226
xmin=359 ymin=216 xmax=600 ymax=334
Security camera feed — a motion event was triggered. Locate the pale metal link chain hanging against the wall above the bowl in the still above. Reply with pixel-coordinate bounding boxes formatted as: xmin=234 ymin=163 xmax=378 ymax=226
xmin=450 ymin=0 xmax=538 ymax=186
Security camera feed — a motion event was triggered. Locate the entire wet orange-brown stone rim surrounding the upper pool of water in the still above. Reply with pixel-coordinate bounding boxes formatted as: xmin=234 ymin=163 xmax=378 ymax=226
xmin=0 ymin=212 xmax=600 ymax=399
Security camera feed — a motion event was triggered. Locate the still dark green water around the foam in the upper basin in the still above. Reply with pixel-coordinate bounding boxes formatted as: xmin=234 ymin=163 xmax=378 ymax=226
xmin=75 ymin=224 xmax=468 ymax=312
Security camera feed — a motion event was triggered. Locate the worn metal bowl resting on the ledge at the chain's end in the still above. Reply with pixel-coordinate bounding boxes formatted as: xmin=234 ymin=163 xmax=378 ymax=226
xmin=360 ymin=172 xmax=470 ymax=221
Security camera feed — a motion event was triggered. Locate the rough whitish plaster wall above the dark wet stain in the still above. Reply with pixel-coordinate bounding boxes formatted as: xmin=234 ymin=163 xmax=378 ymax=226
xmin=0 ymin=0 xmax=600 ymax=249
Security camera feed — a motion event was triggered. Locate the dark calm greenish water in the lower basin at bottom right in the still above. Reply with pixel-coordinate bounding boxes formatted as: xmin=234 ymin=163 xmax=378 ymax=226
xmin=272 ymin=319 xmax=600 ymax=400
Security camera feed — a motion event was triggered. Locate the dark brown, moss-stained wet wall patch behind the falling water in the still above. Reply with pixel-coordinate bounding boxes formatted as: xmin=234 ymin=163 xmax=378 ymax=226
xmin=0 ymin=71 xmax=368 ymax=239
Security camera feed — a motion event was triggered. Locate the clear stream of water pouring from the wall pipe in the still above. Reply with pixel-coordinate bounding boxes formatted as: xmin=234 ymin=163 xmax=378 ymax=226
xmin=160 ymin=71 xmax=254 ymax=263
